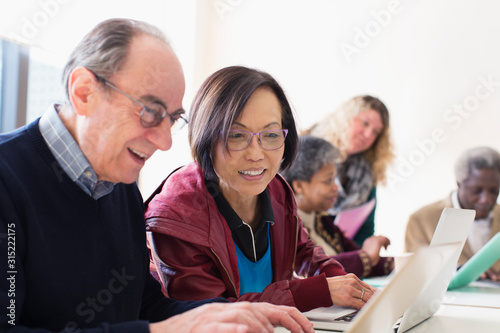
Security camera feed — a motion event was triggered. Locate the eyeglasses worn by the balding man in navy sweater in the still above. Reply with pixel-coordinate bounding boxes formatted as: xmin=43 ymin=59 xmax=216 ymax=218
xmin=91 ymin=71 xmax=187 ymax=134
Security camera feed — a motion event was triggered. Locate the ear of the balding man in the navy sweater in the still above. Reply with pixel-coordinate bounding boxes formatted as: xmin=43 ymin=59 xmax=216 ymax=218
xmin=68 ymin=67 xmax=99 ymax=116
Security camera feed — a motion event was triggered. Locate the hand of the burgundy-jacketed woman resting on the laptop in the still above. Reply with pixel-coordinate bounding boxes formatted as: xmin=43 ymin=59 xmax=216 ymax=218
xmin=326 ymin=274 xmax=377 ymax=309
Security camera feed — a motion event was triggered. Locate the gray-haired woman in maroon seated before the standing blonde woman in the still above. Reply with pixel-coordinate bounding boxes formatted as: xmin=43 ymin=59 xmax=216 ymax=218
xmin=282 ymin=136 xmax=394 ymax=278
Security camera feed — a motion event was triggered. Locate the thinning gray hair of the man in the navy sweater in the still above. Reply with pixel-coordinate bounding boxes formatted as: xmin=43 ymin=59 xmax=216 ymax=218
xmin=62 ymin=19 xmax=169 ymax=101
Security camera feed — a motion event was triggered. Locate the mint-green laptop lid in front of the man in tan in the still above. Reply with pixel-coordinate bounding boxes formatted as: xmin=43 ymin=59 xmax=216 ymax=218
xmin=448 ymin=232 xmax=500 ymax=290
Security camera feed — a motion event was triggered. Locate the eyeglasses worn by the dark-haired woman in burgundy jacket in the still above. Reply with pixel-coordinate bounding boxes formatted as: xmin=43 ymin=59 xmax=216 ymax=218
xmin=221 ymin=129 xmax=288 ymax=151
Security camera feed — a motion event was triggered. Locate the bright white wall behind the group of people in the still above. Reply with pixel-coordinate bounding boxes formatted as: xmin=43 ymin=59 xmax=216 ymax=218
xmin=0 ymin=0 xmax=500 ymax=252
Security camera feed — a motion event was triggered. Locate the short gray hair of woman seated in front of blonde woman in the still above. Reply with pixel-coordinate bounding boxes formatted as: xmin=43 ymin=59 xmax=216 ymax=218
xmin=282 ymin=135 xmax=340 ymax=186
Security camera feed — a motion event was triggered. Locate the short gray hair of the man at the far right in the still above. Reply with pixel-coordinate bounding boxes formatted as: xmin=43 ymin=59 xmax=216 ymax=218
xmin=455 ymin=147 xmax=500 ymax=183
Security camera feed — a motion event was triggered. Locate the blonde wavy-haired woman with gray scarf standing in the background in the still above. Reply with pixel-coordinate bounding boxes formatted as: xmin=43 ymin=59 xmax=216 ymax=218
xmin=308 ymin=95 xmax=394 ymax=245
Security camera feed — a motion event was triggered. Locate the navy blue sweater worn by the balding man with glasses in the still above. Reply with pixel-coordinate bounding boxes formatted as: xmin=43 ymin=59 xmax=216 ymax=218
xmin=0 ymin=121 xmax=219 ymax=333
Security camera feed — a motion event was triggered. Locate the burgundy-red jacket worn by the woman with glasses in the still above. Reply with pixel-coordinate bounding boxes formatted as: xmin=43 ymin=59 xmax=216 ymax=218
xmin=146 ymin=163 xmax=346 ymax=311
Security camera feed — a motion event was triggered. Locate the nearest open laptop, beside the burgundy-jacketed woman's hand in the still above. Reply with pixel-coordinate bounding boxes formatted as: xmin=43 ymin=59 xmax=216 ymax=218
xmin=304 ymin=242 xmax=460 ymax=333
